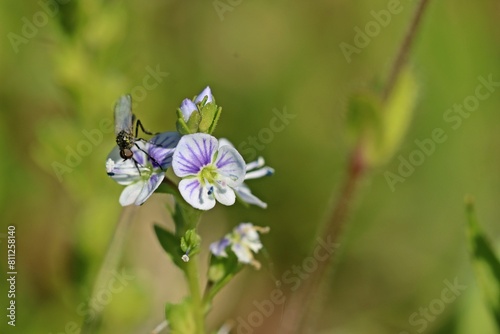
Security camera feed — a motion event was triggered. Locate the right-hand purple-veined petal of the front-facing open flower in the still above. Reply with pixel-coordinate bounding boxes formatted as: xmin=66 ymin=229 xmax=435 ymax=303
xmin=215 ymin=145 xmax=246 ymax=187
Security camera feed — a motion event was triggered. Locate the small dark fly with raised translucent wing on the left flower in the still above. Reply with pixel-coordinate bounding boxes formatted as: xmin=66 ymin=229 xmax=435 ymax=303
xmin=115 ymin=95 xmax=163 ymax=174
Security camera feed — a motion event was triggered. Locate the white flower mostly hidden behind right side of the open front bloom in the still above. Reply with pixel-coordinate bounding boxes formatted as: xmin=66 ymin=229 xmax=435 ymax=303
xmin=219 ymin=138 xmax=274 ymax=209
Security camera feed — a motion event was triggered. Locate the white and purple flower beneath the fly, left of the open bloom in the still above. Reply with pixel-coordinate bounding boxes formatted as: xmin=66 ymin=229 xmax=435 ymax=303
xmin=106 ymin=132 xmax=180 ymax=206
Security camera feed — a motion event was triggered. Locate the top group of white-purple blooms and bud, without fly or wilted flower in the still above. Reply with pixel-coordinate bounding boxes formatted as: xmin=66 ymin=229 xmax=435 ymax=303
xmin=106 ymin=87 xmax=274 ymax=210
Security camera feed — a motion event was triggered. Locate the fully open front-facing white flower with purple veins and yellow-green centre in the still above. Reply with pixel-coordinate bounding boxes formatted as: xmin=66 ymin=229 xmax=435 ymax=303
xmin=172 ymin=133 xmax=246 ymax=210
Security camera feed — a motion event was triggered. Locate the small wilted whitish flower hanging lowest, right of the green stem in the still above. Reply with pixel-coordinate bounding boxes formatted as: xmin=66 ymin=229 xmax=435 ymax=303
xmin=210 ymin=223 xmax=269 ymax=268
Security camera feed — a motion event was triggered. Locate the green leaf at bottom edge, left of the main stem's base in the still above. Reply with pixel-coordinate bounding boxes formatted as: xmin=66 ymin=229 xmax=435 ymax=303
xmin=165 ymin=298 xmax=196 ymax=334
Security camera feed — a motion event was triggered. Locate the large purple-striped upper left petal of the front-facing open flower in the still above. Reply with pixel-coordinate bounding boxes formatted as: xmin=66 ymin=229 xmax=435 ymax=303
xmin=172 ymin=133 xmax=217 ymax=177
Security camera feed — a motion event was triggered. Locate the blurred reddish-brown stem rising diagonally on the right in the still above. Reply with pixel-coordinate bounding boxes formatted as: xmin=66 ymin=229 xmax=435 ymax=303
xmin=281 ymin=0 xmax=429 ymax=333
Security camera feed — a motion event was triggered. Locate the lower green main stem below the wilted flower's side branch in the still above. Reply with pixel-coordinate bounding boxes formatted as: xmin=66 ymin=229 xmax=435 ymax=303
xmin=185 ymin=256 xmax=205 ymax=334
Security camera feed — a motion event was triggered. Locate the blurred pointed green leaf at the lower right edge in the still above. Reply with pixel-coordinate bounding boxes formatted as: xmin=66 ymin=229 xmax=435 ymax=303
xmin=466 ymin=199 xmax=500 ymax=330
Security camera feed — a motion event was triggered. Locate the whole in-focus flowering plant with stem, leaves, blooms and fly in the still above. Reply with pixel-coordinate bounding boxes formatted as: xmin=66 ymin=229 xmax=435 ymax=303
xmin=106 ymin=87 xmax=274 ymax=333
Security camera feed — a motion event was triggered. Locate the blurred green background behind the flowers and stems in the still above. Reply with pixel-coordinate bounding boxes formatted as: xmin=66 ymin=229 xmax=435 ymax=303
xmin=0 ymin=0 xmax=500 ymax=334
